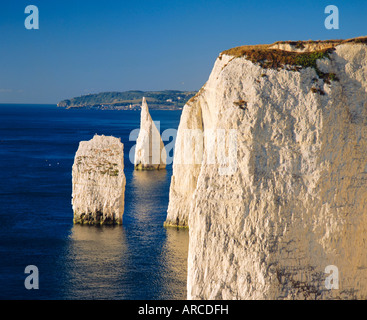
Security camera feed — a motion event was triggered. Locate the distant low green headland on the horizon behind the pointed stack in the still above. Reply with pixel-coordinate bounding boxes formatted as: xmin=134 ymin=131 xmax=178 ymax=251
xmin=57 ymin=90 xmax=196 ymax=110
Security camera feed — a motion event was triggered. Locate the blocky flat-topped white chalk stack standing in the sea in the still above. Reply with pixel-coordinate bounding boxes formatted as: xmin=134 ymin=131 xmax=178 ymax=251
xmin=72 ymin=135 xmax=126 ymax=224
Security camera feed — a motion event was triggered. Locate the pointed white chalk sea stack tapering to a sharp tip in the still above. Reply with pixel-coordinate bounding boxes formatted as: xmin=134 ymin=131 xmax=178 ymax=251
xmin=134 ymin=98 xmax=167 ymax=170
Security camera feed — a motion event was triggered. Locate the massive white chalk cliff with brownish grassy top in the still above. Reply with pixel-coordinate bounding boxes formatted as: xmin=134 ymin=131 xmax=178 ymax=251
xmin=166 ymin=38 xmax=367 ymax=299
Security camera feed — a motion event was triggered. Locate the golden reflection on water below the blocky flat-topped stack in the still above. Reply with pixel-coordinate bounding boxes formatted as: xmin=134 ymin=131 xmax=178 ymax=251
xmin=65 ymin=225 xmax=128 ymax=299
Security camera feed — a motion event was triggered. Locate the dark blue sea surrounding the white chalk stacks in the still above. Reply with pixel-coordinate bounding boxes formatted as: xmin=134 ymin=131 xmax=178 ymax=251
xmin=0 ymin=105 xmax=188 ymax=300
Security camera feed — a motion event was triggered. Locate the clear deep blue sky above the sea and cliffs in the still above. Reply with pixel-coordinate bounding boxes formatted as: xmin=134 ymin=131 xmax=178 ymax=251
xmin=0 ymin=0 xmax=367 ymax=103
